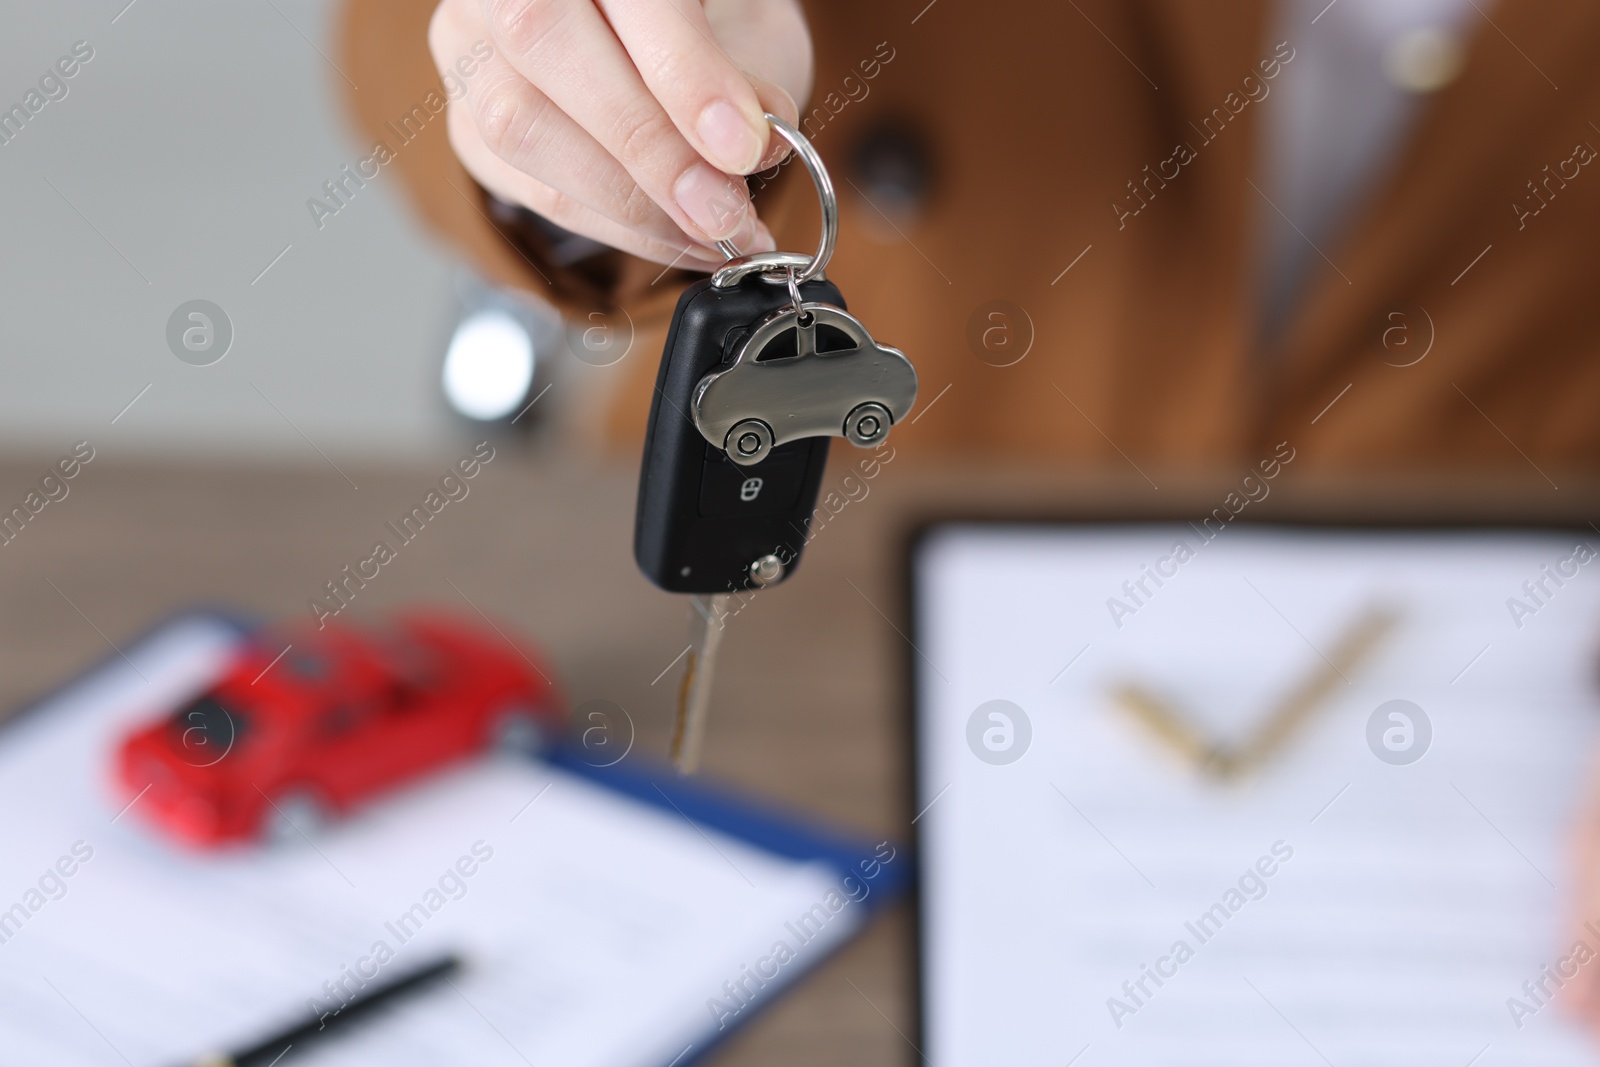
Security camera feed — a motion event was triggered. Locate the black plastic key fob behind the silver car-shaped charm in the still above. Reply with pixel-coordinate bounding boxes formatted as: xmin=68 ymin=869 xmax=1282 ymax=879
xmin=634 ymin=275 xmax=845 ymax=593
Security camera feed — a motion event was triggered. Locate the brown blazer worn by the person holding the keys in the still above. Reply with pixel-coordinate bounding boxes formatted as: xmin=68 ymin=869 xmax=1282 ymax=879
xmin=342 ymin=0 xmax=1600 ymax=483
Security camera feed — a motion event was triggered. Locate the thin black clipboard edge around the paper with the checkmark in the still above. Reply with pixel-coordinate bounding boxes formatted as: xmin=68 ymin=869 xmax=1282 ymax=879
xmin=899 ymin=511 xmax=1600 ymax=1067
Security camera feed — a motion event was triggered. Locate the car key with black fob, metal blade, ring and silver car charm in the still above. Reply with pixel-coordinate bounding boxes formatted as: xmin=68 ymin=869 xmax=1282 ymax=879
xmin=634 ymin=115 xmax=917 ymax=773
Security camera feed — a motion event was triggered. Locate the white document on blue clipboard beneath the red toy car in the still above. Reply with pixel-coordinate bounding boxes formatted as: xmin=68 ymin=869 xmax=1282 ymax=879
xmin=0 ymin=619 xmax=864 ymax=1067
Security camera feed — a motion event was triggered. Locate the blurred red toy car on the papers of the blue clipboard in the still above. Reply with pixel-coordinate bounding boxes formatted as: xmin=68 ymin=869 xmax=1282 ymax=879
xmin=115 ymin=616 xmax=562 ymax=846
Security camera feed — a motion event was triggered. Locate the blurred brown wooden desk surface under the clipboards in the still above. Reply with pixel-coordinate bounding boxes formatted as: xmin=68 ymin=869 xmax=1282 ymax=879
xmin=0 ymin=446 xmax=1574 ymax=1067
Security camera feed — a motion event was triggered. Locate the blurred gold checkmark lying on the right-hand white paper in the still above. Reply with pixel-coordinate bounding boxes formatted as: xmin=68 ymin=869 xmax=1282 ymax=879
xmin=1112 ymin=606 xmax=1398 ymax=781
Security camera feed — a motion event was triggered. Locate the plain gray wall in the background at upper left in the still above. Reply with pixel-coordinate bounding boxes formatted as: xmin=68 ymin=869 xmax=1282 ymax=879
xmin=0 ymin=0 xmax=466 ymax=462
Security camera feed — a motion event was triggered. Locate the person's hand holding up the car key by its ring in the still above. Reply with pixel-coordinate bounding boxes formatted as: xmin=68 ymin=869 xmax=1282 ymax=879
xmin=429 ymin=0 xmax=811 ymax=270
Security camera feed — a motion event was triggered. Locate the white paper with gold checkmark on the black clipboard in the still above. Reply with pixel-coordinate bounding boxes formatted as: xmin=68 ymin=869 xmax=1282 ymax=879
xmin=914 ymin=525 xmax=1600 ymax=1067
